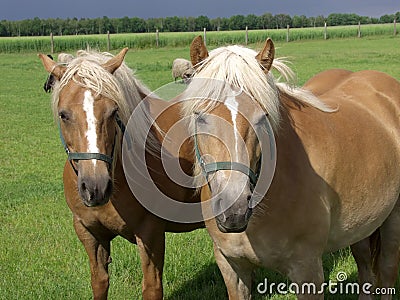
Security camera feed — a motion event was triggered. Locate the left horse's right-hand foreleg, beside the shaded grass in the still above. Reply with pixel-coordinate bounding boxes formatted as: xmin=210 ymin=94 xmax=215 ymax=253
xmin=136 ymin=222 xmax=165 ymax=300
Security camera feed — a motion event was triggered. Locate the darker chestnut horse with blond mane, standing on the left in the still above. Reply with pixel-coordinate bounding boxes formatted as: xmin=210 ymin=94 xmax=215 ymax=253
xmin=39 ymin=48 xmax=204 ymax=299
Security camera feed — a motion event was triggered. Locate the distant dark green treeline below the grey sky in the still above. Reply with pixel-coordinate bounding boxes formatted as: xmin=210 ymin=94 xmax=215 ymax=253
xmin=0 ymin=12 xmax=400 ymax=36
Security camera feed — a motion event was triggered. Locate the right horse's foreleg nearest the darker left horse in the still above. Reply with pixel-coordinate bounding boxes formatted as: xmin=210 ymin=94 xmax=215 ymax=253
xmin=214 ymin=243 xmax=253 ymax=300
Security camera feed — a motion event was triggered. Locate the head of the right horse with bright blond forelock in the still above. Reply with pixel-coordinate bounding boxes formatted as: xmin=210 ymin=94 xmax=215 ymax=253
xmin=184 ymin=37 xmax=275 ymax=232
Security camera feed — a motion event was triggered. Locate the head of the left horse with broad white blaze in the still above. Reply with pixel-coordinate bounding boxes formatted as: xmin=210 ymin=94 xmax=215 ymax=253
xmin=39 ymin=48 xmax=128 ymax=207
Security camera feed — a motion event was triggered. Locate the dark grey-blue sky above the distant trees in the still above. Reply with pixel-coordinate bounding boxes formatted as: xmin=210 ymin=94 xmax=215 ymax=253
xmin=0 ymin=0 xmax=400 ymax=20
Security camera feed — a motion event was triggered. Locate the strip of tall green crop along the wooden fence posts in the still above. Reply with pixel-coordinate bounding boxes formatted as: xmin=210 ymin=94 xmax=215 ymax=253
xmin=0 ymin=21 xmax=398 ymax=53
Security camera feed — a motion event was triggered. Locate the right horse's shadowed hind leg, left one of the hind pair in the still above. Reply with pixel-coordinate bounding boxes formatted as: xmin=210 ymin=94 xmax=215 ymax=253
xmin=351 ymin=238 xmax=376 ymax=300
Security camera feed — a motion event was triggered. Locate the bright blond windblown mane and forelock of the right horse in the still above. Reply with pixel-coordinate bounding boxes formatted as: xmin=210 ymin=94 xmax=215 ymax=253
xmin=183 ymin=45 xmax=333 ymax=129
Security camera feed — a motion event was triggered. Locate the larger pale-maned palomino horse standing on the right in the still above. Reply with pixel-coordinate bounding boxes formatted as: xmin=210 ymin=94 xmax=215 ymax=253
xmin=183 ymin=37 xmax=400 ymax=299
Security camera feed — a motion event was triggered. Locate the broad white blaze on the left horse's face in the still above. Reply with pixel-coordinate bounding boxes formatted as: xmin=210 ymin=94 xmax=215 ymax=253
xmin=83 ymin=91 xmax=99 ymax=166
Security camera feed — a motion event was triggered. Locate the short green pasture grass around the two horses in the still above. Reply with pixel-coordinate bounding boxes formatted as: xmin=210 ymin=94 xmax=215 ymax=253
xmin=0 ymin=37 xmax=400 ymax=300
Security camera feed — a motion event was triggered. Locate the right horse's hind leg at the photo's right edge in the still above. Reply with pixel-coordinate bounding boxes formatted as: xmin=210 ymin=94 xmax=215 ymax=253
xmin=375 ymin=199 xmax=400 ymax=300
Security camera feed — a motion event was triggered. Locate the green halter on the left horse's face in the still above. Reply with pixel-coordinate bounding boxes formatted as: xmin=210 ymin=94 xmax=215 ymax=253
xmin=58 ymin=115 xmax=125 ymax=174
